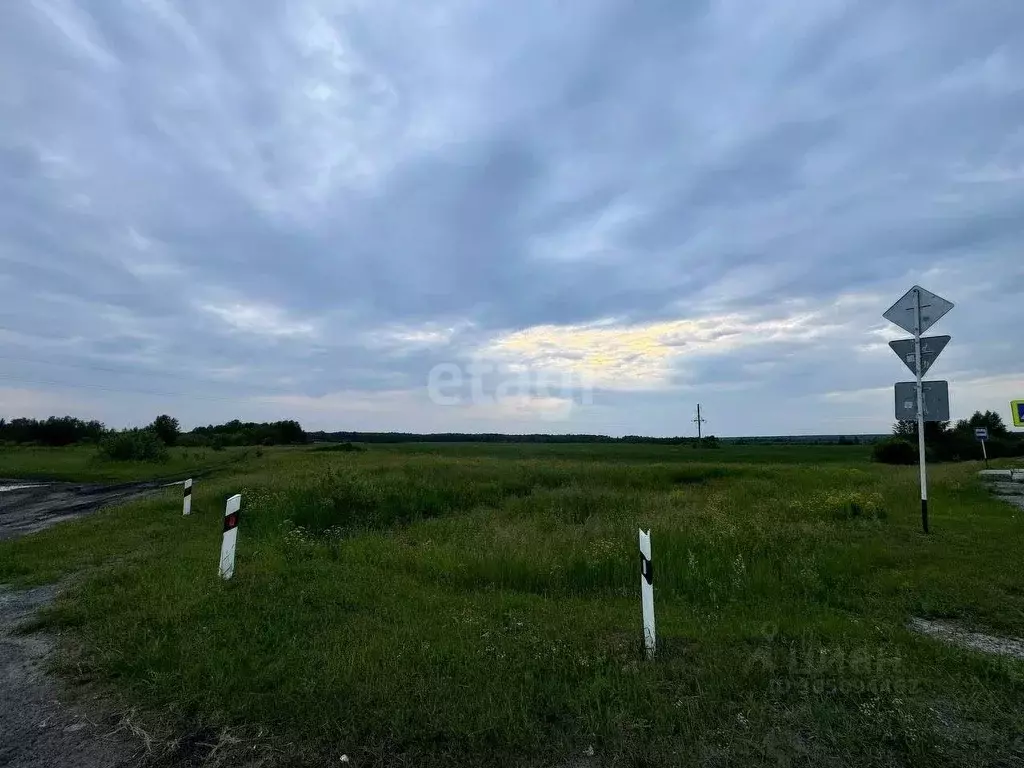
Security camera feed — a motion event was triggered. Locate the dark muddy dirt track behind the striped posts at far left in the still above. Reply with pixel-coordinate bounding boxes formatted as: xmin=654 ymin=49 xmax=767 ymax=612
xmin=0 ymin=480 xmax=173 ymax=541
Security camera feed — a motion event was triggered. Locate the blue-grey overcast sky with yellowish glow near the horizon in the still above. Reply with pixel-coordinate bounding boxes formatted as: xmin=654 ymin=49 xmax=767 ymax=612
xmin=0 ymin=0 xmax=1024 ymax=435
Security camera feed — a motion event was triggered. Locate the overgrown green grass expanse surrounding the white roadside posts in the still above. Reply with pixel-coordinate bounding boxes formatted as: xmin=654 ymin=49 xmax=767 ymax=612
xmin=0 ymin=444 xmax=1024 ymax=767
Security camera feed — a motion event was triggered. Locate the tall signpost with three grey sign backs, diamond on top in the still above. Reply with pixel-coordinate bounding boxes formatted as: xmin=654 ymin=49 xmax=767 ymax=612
xmin=882 ymin=286 xmax=953 ymax=534
